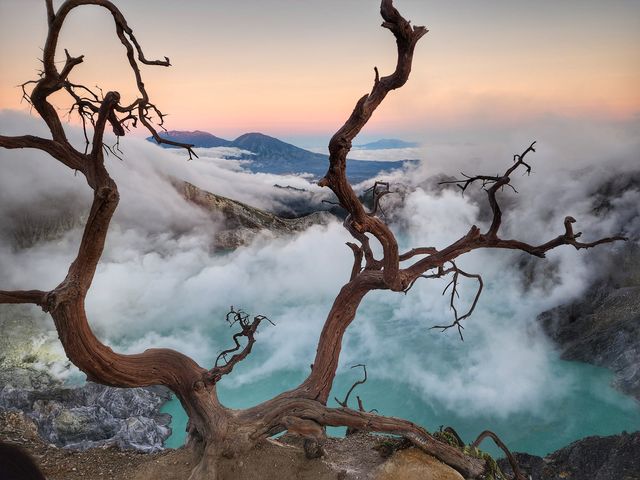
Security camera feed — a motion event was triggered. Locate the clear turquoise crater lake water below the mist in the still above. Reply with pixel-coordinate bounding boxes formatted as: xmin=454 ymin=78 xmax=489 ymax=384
xmin=162 ymin=360 xmax=640 ymax=456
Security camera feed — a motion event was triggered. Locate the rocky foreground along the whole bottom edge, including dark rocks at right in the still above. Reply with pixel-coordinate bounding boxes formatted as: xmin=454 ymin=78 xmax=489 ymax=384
xmin=6 ymin=412 xmax=640 ymax=480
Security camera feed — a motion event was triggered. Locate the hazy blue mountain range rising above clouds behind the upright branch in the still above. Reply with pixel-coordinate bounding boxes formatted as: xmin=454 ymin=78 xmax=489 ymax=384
xmin=147 ymin=130 xmax=413 ymax=183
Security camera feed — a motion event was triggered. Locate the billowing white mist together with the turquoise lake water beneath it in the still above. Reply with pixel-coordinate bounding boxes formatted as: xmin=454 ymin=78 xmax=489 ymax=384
xmin=0 ymin=112 xmax=640 ymax=454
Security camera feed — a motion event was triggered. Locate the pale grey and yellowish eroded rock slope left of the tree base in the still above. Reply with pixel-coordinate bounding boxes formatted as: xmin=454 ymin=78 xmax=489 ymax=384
xmin=0 ymin=306 xmax=171 ymax=452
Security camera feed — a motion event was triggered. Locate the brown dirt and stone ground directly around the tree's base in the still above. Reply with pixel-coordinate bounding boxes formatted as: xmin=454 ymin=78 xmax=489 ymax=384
xmin=0 ymin=412 xmax=462 ymax=480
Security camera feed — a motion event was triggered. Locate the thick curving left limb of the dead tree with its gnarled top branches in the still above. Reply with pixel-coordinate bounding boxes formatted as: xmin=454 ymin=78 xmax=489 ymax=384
xmin=0 ymin=0 xmax=212 ymax=404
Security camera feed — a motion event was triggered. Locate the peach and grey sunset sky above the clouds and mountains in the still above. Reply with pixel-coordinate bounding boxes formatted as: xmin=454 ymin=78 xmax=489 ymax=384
xmin=0 ymin=0 xmax=640 ymax=144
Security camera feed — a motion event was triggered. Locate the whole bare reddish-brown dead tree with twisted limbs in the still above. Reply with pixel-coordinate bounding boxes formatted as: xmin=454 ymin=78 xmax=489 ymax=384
xmin=0 ymin=0 xmax=621 ymax=479
